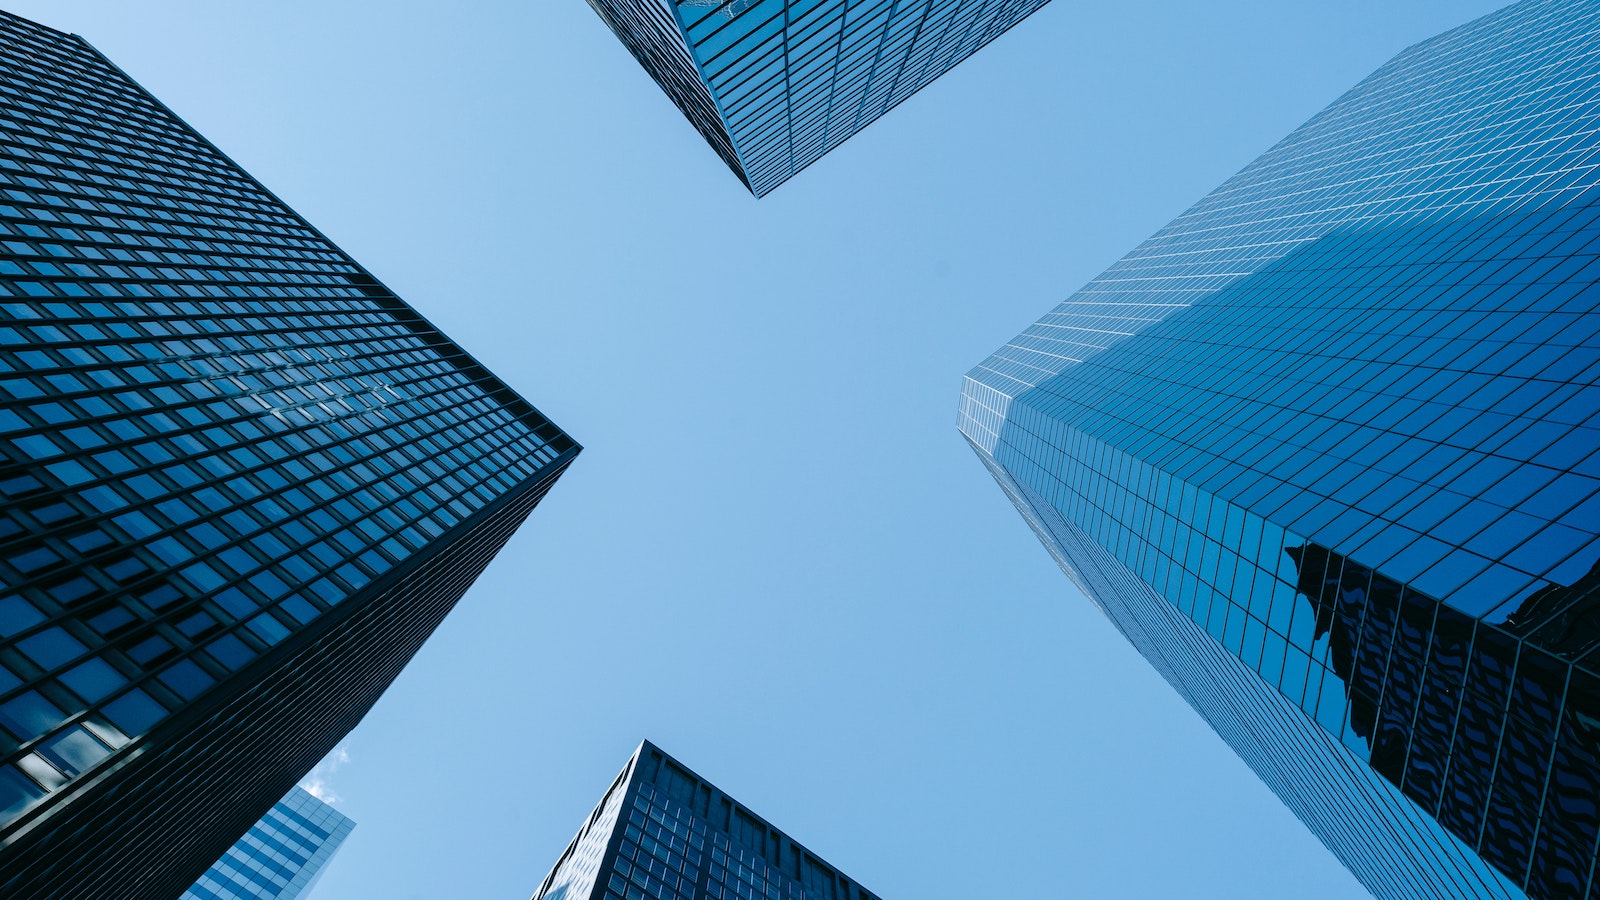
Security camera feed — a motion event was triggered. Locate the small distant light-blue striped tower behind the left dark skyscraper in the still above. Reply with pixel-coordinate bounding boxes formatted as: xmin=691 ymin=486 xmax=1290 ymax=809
xmin=178 ymin=788 xmax=355 ymax=900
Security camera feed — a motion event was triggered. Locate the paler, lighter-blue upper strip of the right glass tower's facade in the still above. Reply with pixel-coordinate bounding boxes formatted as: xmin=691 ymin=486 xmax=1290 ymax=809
xmin=960 ymin=0 xmax=1600 ymax=422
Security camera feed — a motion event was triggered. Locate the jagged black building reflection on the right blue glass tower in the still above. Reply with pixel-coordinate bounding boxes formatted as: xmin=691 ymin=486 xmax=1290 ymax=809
xmin=1285 ymin=544 xmax=1600 ymax=897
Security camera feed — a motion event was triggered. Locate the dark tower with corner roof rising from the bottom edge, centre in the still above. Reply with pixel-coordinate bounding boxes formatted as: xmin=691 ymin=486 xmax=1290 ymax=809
xmin=533 ymin=741 xmax=877 ymax=900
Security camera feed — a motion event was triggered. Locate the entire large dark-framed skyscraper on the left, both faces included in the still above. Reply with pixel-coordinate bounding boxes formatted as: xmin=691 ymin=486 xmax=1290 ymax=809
xmin=0 ymin=8 xmax=578 ymax=900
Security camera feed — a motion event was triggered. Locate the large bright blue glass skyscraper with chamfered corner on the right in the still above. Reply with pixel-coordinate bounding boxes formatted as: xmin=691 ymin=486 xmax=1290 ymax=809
xmin=960 ymin=0 xmax=1600 ymax=897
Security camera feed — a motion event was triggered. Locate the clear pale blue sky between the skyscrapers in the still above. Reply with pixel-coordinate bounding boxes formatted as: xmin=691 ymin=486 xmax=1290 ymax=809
xmin=0 ymin=0 xmax=1501 ymax=900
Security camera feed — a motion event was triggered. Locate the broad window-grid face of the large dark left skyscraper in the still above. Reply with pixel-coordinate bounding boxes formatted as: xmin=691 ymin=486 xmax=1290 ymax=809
xmin=0 ymin=8 xmax=576 ymax=833
